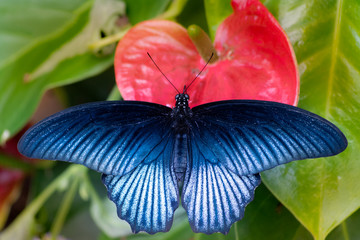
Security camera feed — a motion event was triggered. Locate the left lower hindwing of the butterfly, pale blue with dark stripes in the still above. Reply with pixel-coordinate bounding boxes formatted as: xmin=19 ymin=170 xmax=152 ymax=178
xmin=102 ymin=129 xmax=179 ymax=234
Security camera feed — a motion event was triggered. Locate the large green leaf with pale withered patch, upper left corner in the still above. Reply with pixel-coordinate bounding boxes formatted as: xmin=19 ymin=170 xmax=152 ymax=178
xmin=0 ymin=0 xmax=124 ymax=143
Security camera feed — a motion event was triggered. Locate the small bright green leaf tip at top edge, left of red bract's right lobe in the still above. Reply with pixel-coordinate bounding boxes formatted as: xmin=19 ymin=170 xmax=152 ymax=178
xmin=204 ymin=0 xmax=233 ymax=40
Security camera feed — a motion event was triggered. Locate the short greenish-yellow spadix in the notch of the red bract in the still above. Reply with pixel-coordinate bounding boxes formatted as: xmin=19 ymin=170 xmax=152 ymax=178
xmin=187 ymin=25 xmax=219 ymax=64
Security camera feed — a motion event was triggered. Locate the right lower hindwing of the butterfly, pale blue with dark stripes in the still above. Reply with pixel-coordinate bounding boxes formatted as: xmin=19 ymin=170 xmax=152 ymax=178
xmin=182 ymin=121 xmax=261 ymax=234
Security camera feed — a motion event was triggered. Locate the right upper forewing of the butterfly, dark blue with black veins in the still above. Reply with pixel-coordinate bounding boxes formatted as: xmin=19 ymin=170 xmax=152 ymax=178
xmin=192 ymin=100 xmax=347 ymax=176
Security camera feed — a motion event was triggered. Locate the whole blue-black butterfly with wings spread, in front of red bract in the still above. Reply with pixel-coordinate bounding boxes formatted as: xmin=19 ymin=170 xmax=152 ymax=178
xmin=18 ymin=93 xmax=347 ymax=234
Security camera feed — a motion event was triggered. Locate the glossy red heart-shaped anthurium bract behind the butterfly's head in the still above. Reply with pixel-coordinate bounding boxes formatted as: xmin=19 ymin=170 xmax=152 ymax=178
xmin=115 ymin=0 xmax=299 ymax=107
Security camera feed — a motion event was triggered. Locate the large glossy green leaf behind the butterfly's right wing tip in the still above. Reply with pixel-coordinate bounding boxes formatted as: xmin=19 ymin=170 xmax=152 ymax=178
xmin=262 ymin=0 xmax=360 ymax=240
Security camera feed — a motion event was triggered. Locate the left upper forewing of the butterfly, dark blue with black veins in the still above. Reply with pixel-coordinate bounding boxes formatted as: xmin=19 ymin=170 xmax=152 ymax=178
xmin=18 ymin=101 xmax=171 ymax=175
